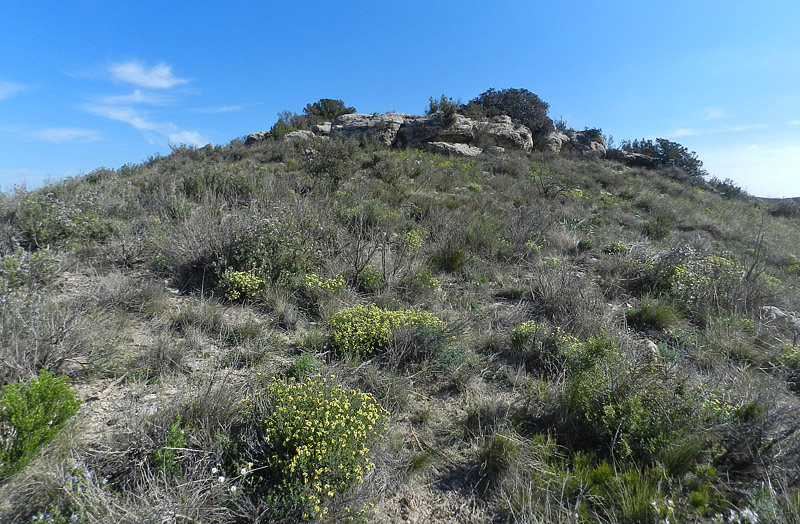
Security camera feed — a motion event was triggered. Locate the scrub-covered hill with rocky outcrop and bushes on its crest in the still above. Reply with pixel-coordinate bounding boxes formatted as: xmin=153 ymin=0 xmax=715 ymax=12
xmin=0 ymin=90 xmax=800 ymax=523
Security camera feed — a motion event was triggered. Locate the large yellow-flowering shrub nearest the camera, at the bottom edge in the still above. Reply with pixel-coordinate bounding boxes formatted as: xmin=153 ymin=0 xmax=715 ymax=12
xmin=263 ymin=375 xmax=388 ymax=520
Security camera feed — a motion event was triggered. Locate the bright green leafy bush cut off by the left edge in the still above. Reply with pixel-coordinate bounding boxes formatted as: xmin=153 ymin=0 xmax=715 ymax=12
xmin=0 ymin=370 xmax=81 ymax=478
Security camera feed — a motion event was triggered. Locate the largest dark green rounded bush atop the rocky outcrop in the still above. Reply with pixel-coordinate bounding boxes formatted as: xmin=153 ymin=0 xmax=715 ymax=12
xmin=464 ymin=88 xmax=554 ymax=140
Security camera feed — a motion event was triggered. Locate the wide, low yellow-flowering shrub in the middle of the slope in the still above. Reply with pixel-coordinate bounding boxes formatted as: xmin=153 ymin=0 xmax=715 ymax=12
xmin=330 ymin=304 xmax=445 ymax=356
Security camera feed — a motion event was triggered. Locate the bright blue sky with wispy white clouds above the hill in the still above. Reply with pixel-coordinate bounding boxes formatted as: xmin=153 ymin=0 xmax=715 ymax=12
xmin=0 ymin=0 xmax=800 ymax=197
